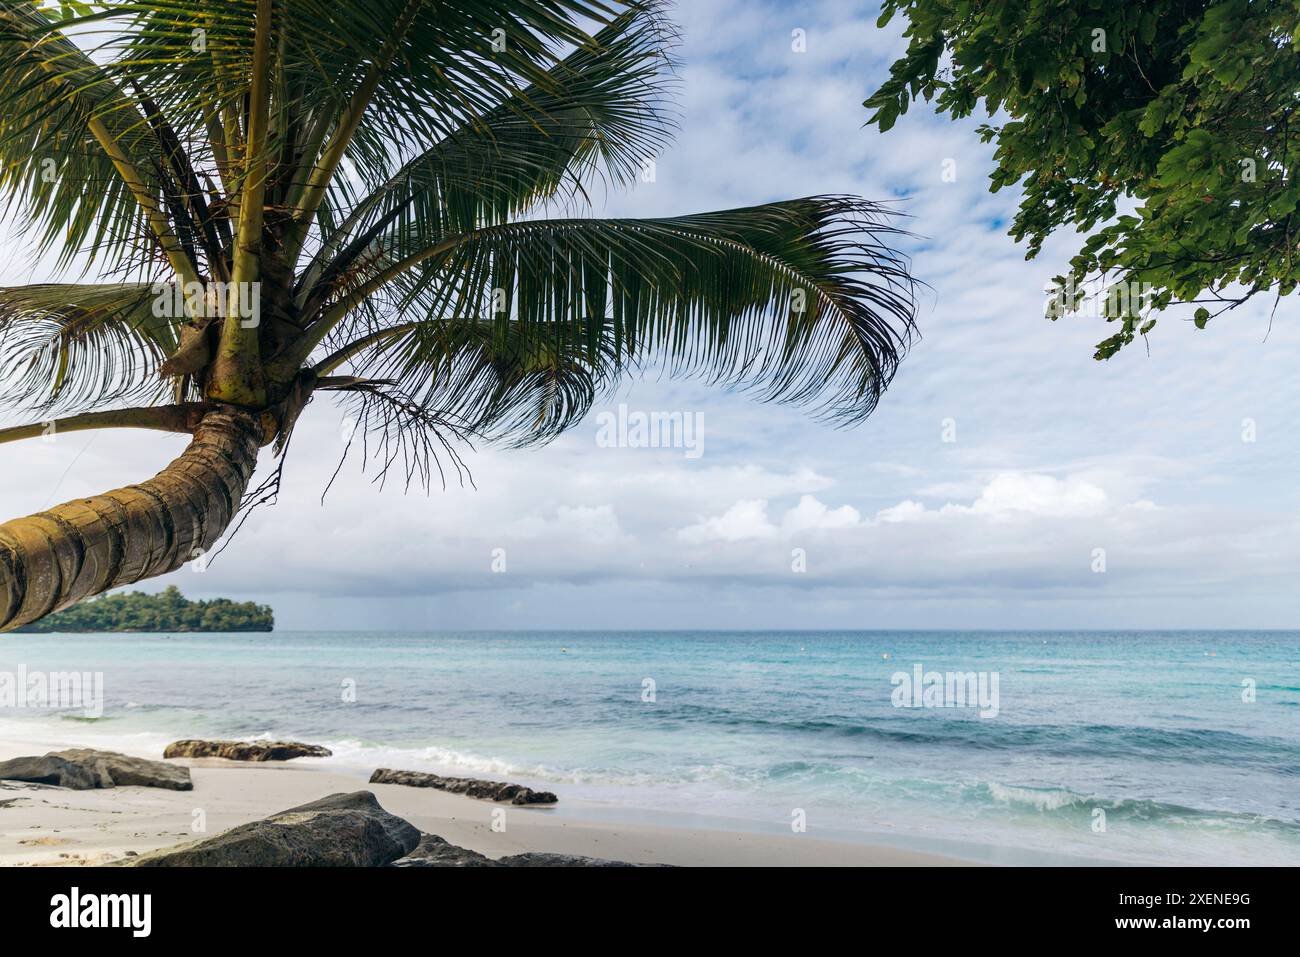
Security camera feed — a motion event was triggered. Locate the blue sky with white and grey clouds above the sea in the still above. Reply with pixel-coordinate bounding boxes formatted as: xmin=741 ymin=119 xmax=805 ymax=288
xmin=0 ymin=0 xmax=1300 ymax=629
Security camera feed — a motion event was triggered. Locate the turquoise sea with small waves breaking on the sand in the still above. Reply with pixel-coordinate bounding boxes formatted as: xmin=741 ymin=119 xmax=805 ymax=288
xmin=0 ymin=632 xmax=1300 ymax=865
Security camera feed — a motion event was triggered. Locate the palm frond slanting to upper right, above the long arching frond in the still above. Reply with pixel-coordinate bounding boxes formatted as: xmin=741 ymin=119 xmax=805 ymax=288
xmin=299 ymin=5 xmax=676 ymax=302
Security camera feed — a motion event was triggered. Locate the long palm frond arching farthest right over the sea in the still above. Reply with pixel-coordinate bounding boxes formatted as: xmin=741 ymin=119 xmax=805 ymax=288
xmin=321 ymin=196 xmax=915 ymax=438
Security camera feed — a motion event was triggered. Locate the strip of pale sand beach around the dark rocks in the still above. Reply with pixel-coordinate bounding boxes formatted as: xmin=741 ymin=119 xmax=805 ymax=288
xmin=0 ymin=742 xmax=966 ymax=866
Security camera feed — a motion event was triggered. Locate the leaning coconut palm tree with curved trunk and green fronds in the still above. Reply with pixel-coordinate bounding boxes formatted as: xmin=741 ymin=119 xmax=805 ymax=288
xmin=0 ymin=0 xmax=914 ymax=629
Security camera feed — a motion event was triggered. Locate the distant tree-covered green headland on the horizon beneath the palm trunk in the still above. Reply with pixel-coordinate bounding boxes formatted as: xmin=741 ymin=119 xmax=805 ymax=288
xmin=14 ymin=585 xmax=276 ymax=633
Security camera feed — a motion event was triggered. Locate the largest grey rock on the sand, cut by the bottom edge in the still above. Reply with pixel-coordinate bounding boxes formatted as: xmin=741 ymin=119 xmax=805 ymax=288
xmin=124 ymin=791 xmax=420 ymax=867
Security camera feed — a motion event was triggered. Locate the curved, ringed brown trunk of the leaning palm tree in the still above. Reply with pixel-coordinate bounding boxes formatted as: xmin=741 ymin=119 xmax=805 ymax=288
xmin=0 ymin=411 xmax=263 ymax=632
